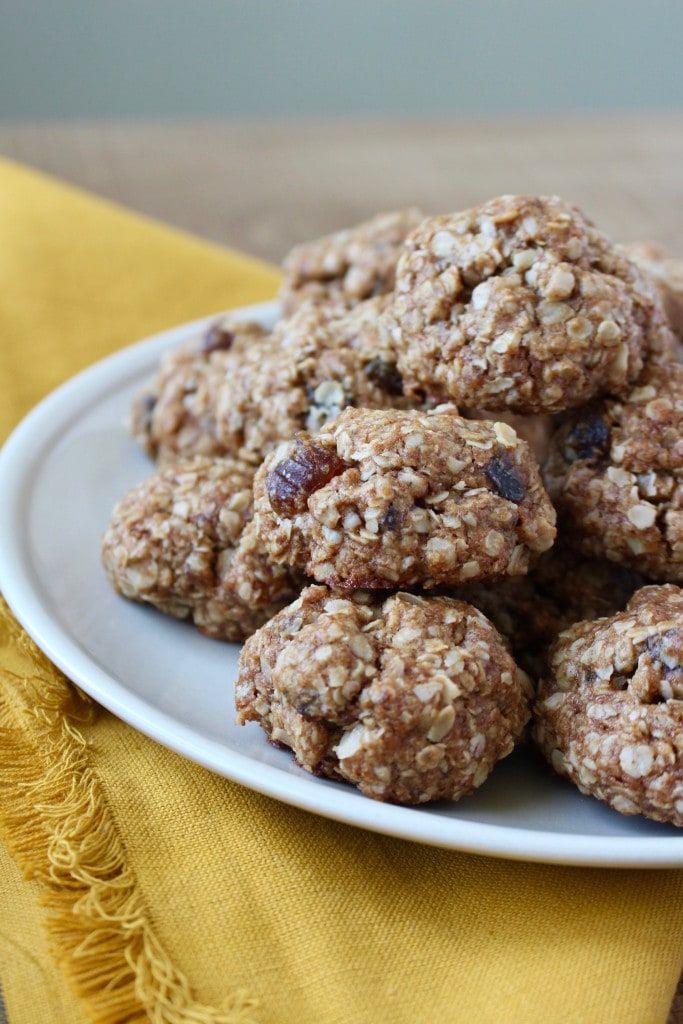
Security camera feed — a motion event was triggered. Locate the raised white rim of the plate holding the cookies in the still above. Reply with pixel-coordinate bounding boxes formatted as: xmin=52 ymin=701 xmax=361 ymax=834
xmin=0 ymin=301 xmax=683 ymax=868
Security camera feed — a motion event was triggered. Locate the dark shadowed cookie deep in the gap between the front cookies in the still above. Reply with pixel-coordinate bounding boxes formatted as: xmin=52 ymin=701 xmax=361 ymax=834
xmin=454 ymin=543 xmax=648 ymax=679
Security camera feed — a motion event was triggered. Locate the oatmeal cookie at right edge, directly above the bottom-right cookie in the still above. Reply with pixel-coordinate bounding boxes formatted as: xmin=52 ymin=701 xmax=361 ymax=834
xmin=544 ymin=362 xmax=683 ymax=583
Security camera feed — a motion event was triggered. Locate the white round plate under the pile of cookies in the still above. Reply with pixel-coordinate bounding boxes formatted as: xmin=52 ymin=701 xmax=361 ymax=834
xmin=0 ymin=303 xmax=683 ymax=867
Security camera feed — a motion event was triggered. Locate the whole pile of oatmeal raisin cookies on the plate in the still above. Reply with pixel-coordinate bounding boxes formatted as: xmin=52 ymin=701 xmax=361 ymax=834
xmin=103 ymin=196 xmax=683 ymax=825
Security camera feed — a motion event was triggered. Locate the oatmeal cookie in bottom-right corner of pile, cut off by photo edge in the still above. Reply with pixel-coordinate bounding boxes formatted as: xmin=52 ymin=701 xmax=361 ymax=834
xmin=533 ymin=586 xmax=683 ymax=827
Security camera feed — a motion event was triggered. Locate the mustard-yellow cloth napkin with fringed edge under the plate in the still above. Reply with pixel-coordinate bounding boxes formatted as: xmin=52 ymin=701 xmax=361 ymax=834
xmin=0 ymin=157 xmax=683 ymax=1024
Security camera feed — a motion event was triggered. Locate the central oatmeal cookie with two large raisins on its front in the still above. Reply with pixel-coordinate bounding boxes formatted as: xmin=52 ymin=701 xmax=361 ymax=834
xmin=254 ymin=406 xmax=555 ymax=589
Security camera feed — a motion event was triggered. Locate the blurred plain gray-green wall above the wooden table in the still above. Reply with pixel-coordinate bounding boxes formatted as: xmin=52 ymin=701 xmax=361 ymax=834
xmin=0 ymin=0 xmax=683 ymax=120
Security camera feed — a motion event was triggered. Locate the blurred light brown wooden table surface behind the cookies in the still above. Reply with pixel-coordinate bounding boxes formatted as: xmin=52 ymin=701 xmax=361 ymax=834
xmin=0 ymin=114 xmax=683 ymax=1024
